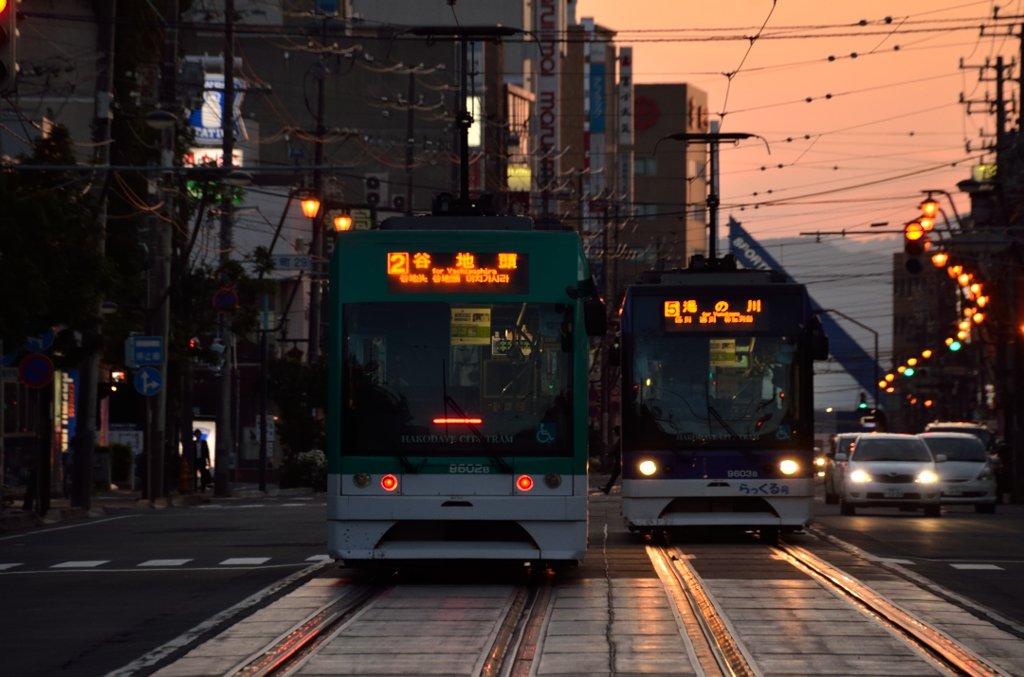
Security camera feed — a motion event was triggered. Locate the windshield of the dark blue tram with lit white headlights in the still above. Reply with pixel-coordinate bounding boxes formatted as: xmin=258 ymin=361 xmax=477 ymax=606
xmin=628 ymin=292 xmax=810 ymax=449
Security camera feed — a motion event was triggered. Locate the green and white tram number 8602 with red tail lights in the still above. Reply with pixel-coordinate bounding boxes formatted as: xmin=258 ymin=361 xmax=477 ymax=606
xmin=328 ymin=216 xmax=606 ymax=565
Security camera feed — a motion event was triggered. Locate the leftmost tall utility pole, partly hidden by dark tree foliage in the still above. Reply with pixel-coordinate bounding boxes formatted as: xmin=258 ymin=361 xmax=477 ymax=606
xmin=72 ymin=0 xmax=117 ymax=509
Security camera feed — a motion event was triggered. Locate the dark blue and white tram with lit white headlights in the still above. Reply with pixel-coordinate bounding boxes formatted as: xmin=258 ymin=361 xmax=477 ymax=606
xmin=622 ymin=257 xmax=828 ymax=541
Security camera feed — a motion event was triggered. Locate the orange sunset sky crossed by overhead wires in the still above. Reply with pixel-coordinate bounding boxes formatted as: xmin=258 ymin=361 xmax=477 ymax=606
xmin=577 ymin=0 xmax=1024 ymax=239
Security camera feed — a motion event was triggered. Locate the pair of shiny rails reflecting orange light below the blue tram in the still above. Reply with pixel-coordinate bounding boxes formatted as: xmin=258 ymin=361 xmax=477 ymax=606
xmin=647 ymin=539 xmax=1012 ymax=677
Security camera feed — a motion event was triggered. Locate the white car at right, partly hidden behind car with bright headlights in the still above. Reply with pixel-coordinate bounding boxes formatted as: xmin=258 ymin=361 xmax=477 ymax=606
xmin=918 ymin=432 xmax=995 ymax=513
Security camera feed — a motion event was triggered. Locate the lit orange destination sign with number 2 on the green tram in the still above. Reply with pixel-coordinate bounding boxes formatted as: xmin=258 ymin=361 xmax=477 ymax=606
xmin=387 ymin=251 xmax=529 ymax=294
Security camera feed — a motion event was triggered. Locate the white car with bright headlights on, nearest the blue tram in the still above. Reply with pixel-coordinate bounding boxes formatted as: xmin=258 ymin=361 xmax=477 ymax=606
xmin=836 ymin=433 xmax=945 ymax=517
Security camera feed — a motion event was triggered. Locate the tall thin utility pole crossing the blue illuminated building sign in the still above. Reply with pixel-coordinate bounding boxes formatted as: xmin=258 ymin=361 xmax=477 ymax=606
xmin=213 ymin=0 xmax=234 ymax=497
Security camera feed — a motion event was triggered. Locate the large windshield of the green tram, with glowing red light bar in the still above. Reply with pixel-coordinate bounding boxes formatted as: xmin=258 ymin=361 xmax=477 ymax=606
xmin=341 ymin=302 xmax=573 ymax=457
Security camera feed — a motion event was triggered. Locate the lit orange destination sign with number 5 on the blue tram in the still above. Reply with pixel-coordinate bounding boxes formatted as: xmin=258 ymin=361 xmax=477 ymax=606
xmin=663 ymin=295 xmax=771 ymax=332
